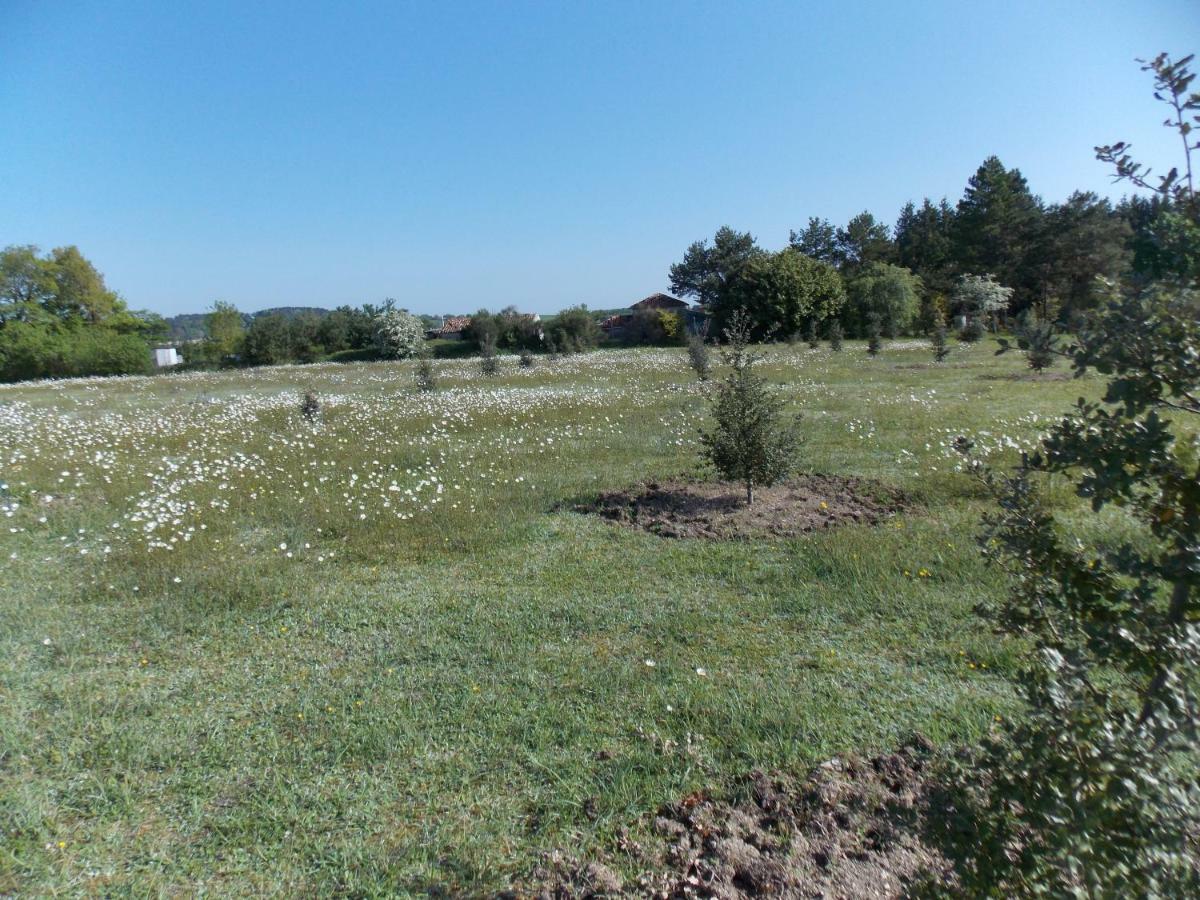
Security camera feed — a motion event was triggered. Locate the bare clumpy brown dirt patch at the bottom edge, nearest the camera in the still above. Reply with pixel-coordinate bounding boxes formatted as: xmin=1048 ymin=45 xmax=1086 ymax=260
xmin=522 ymin=738 xmax=954 ymax=900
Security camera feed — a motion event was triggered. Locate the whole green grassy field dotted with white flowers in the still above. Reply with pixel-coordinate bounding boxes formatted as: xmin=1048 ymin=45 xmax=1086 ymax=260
xmin=0 ymin=341 xmax=1099 ymax=895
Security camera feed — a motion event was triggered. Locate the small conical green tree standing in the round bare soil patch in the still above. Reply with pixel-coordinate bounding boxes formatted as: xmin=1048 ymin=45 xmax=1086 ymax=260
xmin=700 ymin=311 xmax=799 ymax=505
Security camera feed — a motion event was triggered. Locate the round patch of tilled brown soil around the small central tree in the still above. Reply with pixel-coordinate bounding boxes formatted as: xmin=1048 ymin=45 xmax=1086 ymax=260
xmin=574 ymin=475 xmax=908 ymax=539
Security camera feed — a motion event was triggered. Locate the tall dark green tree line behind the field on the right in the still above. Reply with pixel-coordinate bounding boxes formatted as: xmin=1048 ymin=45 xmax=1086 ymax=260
xmin=670 ymin=156 xmax=1200 ymax=338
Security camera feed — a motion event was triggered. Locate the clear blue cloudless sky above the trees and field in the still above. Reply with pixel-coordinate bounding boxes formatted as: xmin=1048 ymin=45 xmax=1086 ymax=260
xmin=0 ymin=0 xmax=1200 ymax=314
